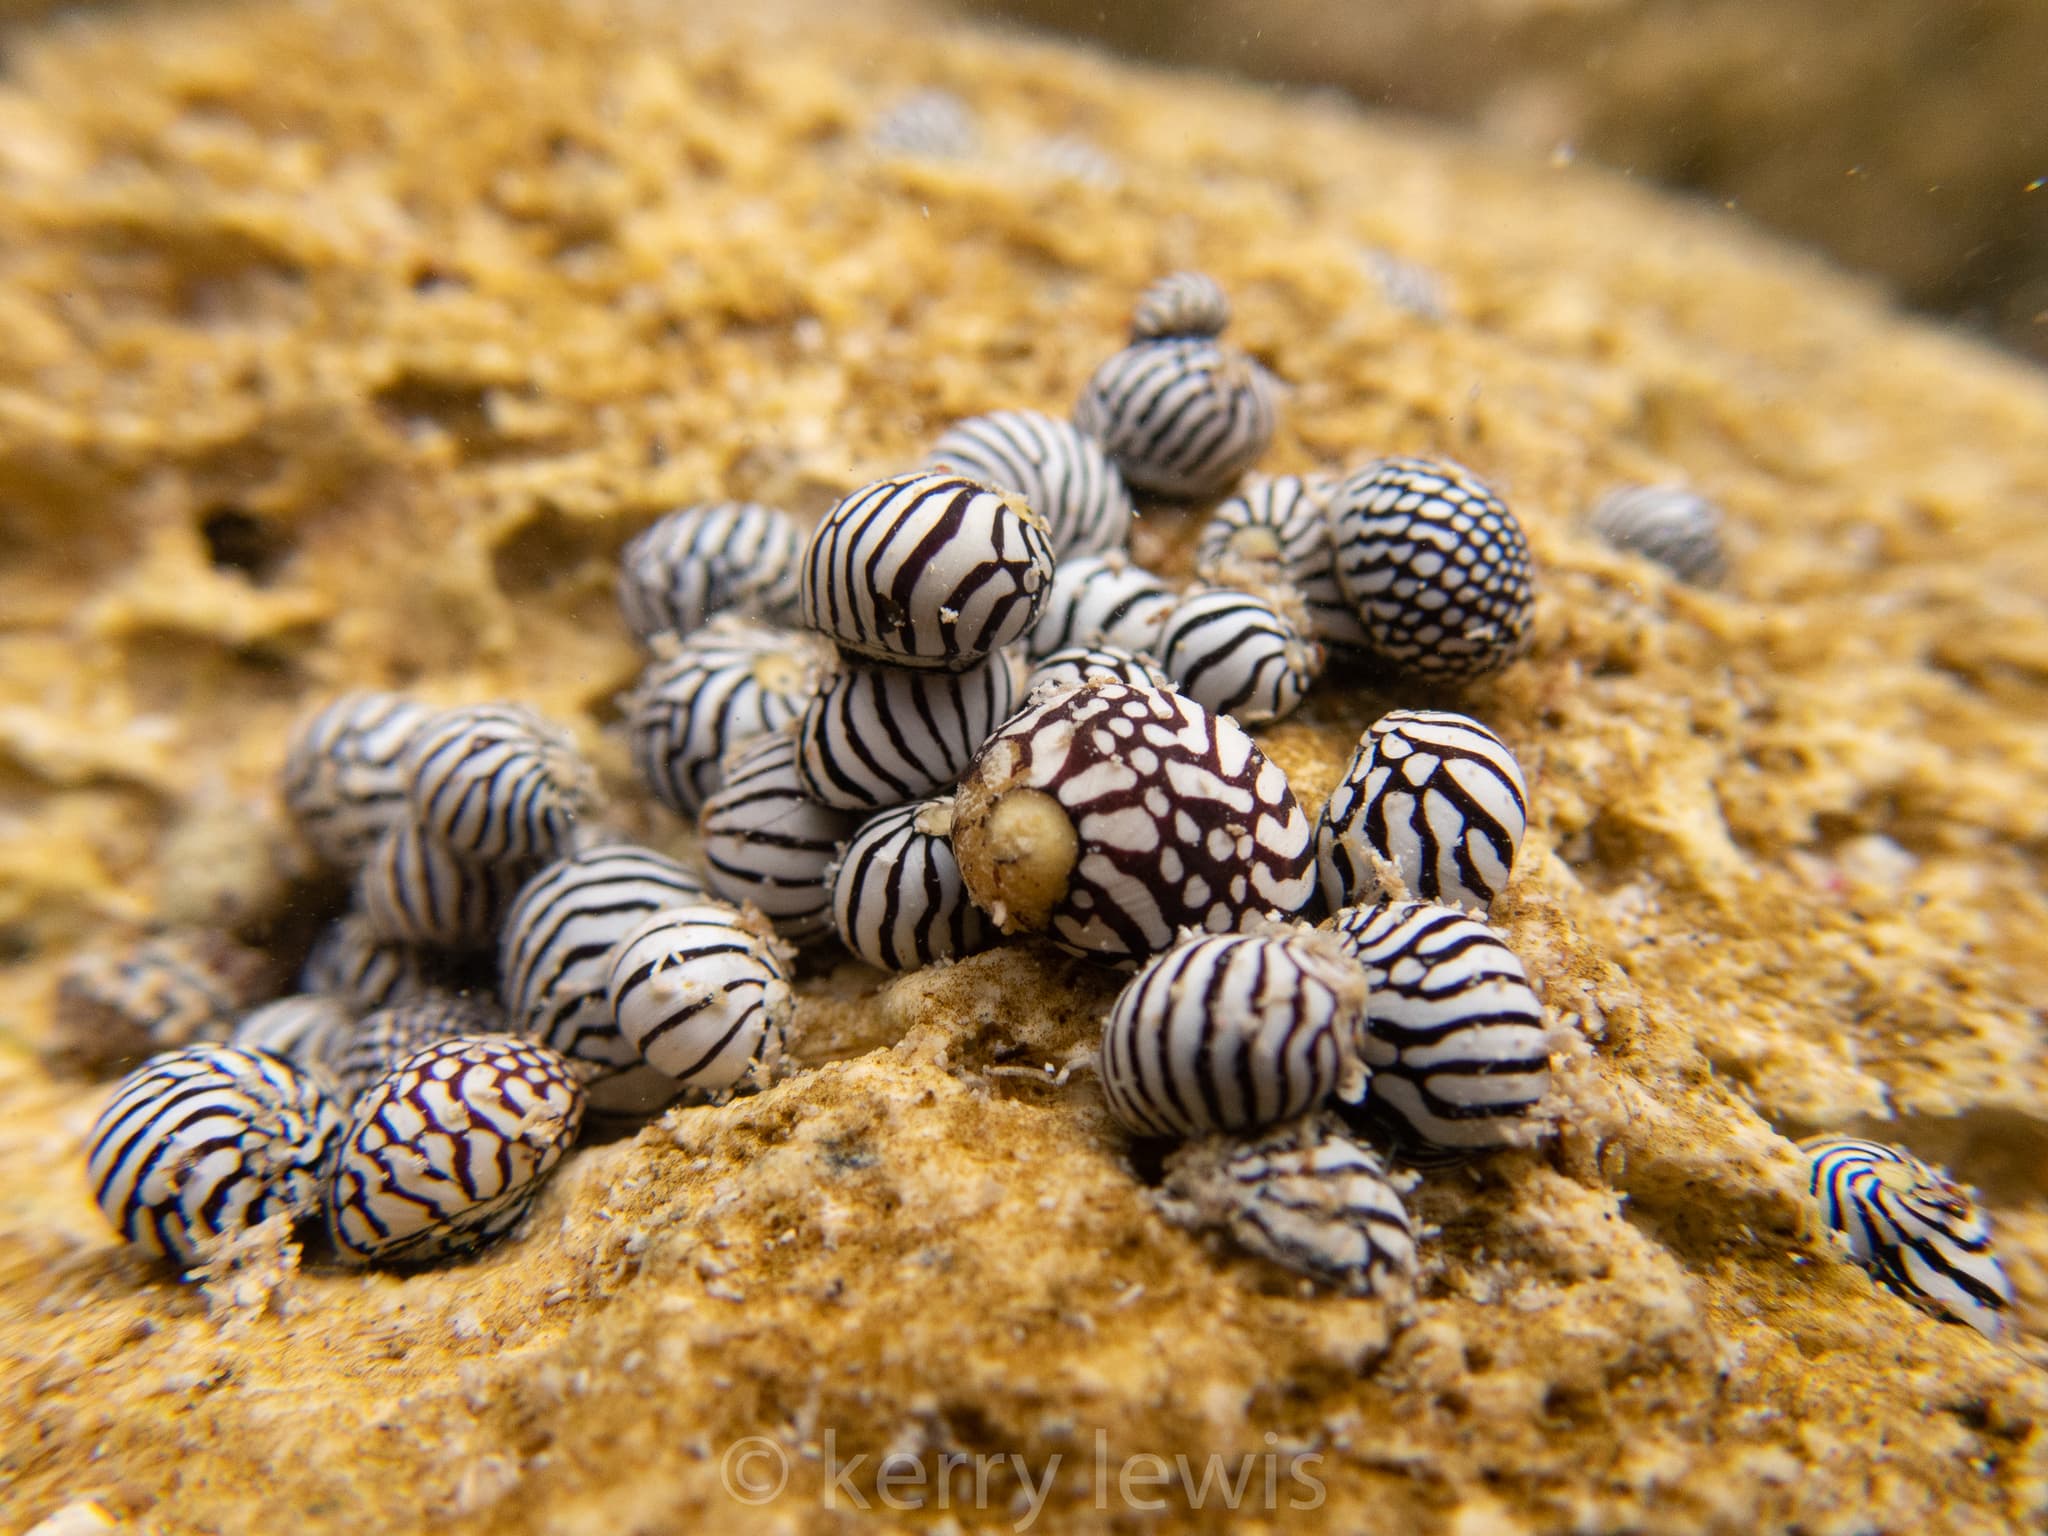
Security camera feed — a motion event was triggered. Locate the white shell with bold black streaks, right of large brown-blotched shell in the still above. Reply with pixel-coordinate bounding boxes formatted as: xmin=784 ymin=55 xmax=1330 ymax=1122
xmin=1315 ymin=709 xmax=1530 ymax=913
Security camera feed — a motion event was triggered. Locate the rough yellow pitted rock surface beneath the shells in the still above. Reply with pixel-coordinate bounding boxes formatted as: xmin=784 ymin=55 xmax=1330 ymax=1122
xmin=0 ymin=0 xmax=2048 ymax=1536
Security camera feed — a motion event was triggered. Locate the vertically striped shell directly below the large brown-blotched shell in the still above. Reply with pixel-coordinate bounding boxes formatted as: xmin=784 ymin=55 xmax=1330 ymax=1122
xmin=1102 ymin=926 xmax=1366 ymax=1137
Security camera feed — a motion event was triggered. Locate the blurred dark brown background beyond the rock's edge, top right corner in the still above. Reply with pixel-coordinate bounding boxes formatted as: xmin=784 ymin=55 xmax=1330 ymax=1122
xmin=952 ymin=0 xmax=2048 ymax=362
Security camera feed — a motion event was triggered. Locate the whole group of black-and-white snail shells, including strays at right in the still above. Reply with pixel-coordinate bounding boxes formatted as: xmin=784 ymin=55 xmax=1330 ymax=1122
xmin=78 ymin=272 xmax=2009 ymax=1327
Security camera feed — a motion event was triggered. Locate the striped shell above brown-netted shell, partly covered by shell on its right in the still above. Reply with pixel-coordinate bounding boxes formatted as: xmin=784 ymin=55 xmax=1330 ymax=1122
xmin=498 ymin=844 xmax=705 ymax=1114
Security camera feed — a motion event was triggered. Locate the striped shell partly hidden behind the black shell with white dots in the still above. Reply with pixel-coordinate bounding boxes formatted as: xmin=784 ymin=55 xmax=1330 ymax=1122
xmin=1194 ymin=475 xmax=1372 ymax=653
